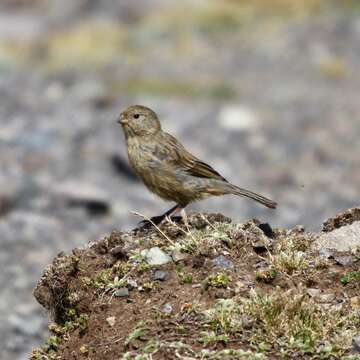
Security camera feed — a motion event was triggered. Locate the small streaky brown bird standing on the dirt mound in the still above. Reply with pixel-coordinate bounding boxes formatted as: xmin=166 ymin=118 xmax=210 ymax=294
xmin=118 ymin=105 xmax=277 ymax=224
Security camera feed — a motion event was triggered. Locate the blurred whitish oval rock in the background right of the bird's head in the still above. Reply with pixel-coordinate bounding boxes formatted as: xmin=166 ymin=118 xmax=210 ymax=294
xmin=219 ymin=104 xmax=258 ymax=131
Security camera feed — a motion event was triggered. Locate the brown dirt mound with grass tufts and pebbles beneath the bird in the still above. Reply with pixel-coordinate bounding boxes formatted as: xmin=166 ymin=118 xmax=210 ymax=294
xmin=32 ymin=214 xmax=360 ymax=360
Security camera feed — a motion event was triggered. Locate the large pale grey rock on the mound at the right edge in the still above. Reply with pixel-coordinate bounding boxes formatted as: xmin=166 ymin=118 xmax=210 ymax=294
xmin=314 ymin=221 xmax=360 ymax=251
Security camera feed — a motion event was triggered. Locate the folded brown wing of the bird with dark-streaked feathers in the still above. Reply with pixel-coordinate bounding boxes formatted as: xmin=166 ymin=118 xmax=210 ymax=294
xmin=164 ymin=133 xmax=227 ymax=182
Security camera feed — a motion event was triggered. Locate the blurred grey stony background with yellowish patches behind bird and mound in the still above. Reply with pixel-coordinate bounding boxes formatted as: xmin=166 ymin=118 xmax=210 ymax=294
xmin=0 ymin=0 xmax=360 ymax=360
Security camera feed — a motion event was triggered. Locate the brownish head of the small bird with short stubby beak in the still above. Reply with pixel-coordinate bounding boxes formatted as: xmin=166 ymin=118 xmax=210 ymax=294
xmin=118 ymin=105 xmax=161 ymax=137
